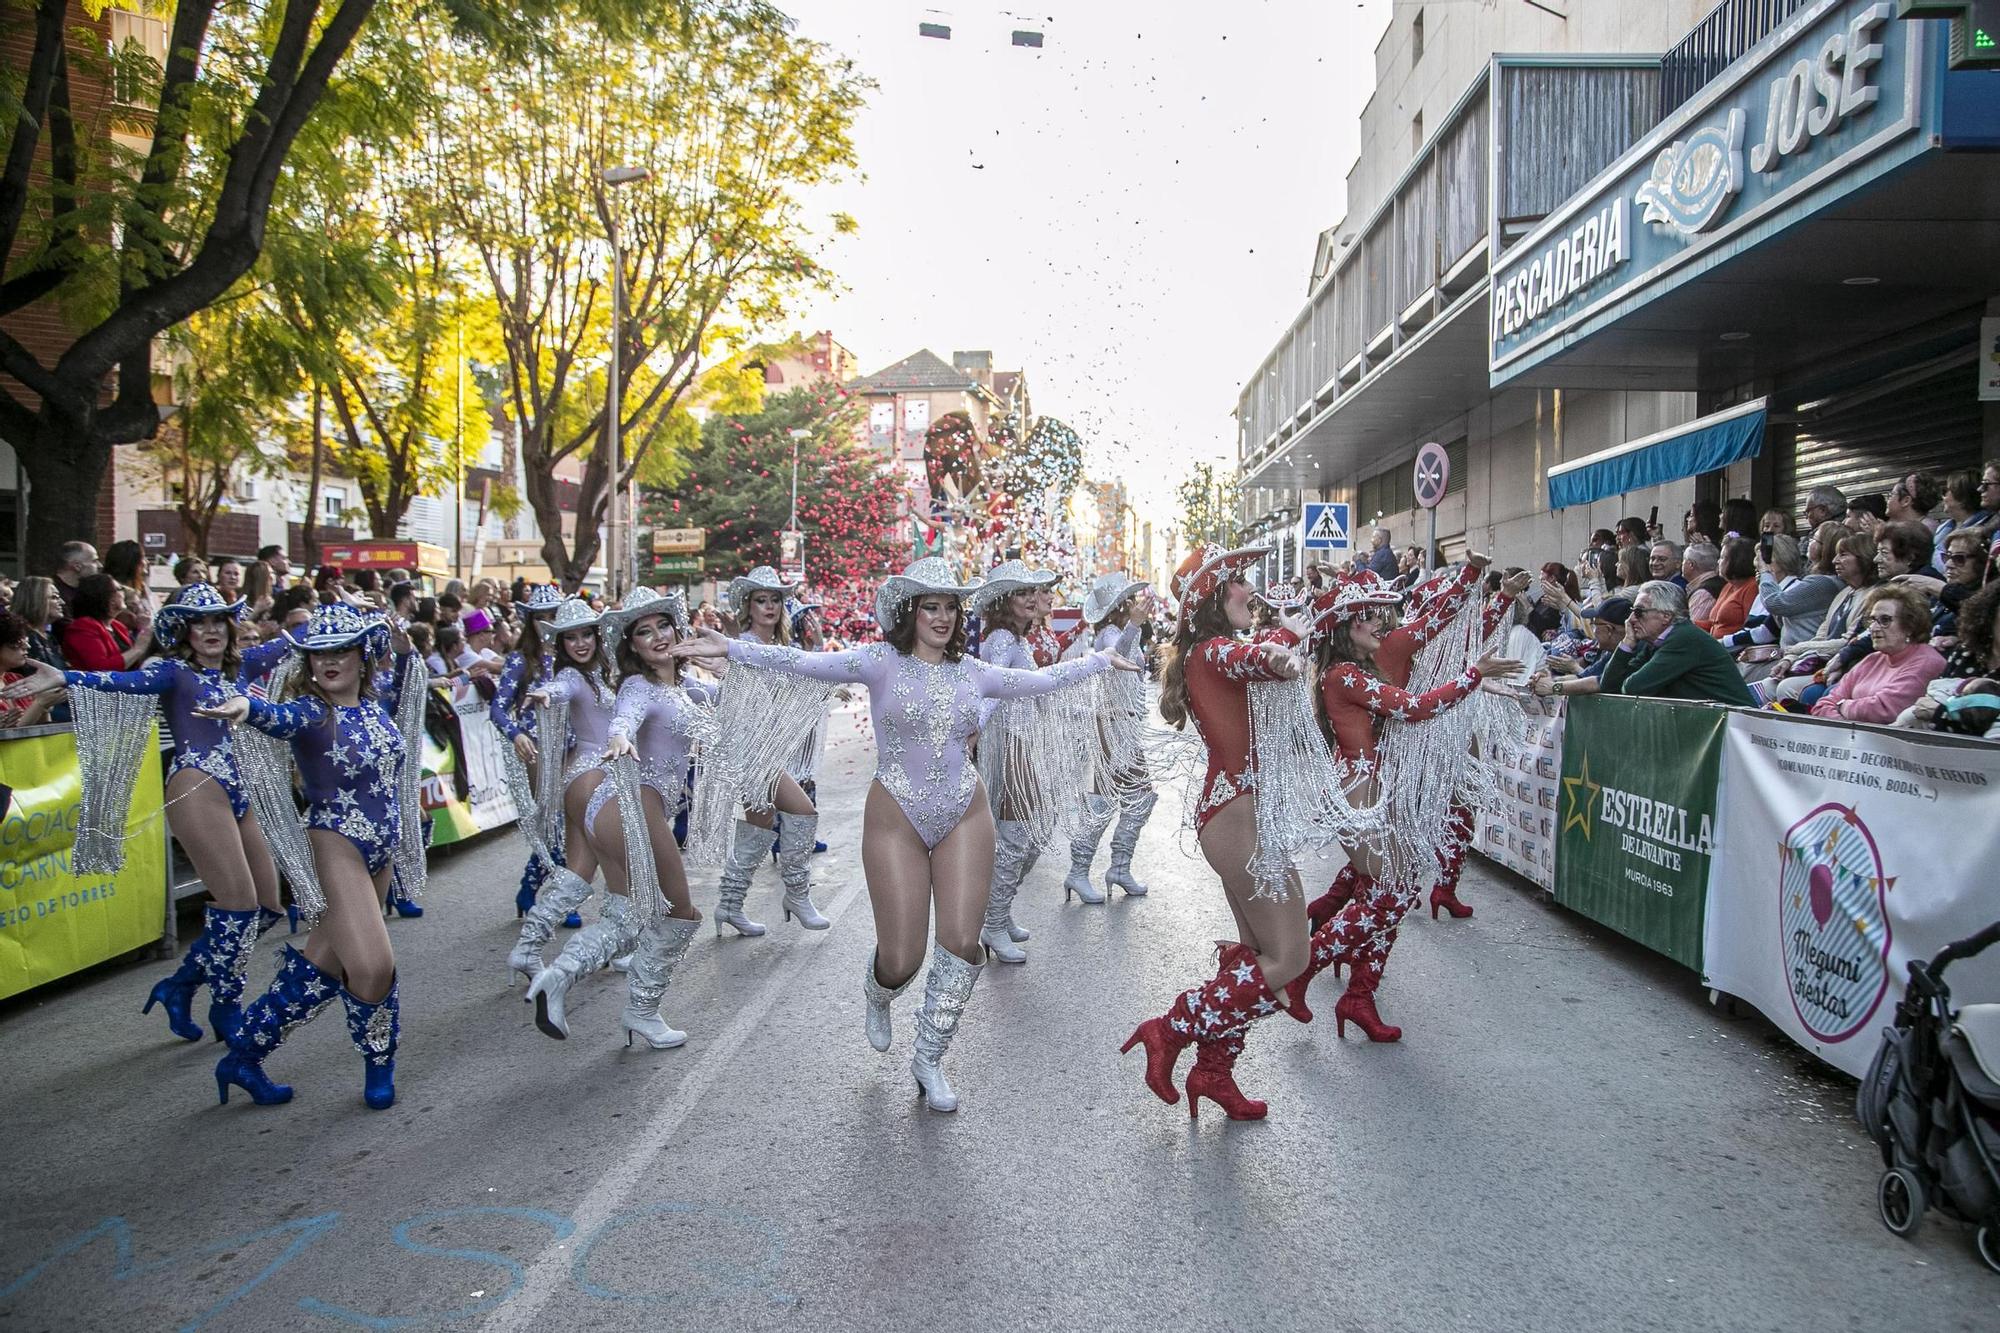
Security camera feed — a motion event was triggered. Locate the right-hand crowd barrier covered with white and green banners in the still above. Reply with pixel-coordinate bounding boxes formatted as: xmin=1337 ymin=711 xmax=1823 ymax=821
xmin=1476 ymin=697 xmax=2000 ymax=1075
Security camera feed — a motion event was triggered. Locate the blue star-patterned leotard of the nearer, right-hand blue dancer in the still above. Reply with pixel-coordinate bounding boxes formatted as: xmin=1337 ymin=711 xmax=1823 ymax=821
xmin=248 ymin=652 xmax=416 ymax=875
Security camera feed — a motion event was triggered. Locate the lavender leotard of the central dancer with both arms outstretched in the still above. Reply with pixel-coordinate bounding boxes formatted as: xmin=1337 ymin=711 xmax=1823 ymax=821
xmin=730 ymin=640 xmax=1110 ymax=849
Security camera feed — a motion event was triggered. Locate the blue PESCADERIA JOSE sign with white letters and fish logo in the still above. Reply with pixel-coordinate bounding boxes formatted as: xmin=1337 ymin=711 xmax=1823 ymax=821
xmin=1488 ymin=0 xmax=1930 ymax=386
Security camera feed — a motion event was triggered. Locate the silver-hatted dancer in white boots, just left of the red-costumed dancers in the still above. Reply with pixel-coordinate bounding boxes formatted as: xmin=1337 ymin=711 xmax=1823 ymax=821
xmin=1062 ymin=572 xmax=1160 ymax=903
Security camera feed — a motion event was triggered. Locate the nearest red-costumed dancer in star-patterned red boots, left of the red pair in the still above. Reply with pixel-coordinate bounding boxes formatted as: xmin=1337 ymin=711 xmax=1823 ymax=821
xmin=1120 ymin=546 xmax=1344 ymax=1121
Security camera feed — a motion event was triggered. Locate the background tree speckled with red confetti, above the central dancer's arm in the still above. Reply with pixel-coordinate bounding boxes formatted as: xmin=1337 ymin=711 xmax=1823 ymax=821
xmin=644 ymin=382 xmax=904 ymax=590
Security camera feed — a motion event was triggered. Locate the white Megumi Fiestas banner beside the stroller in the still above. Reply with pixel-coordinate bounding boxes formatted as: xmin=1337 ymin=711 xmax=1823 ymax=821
xmin=1704 ymin=713 xmax=2000 ymax=1075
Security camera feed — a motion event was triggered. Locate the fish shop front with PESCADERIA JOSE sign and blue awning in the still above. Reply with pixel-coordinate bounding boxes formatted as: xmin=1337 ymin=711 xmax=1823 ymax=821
xmin=1488 ymin=0 xmax=2000 ymax=514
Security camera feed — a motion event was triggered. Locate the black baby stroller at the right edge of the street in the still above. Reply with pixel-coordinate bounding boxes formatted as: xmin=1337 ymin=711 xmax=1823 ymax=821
xmin=1854 ymin=921 xmax=2000 ymax=1273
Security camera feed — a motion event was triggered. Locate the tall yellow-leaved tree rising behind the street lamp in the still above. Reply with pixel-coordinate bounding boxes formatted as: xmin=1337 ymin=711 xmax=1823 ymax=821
xmin=440 ymin=0 xmax=864 ymax=580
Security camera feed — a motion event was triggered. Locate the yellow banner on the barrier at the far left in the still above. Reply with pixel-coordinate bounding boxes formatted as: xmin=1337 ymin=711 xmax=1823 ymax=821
xmin=0 ymin=731 xmax=166 ymax=997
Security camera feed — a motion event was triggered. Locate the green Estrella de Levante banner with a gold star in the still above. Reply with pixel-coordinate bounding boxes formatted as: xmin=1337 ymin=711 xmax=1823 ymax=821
xmin=1556 ymin=695 xmax=1728 ymax=971
